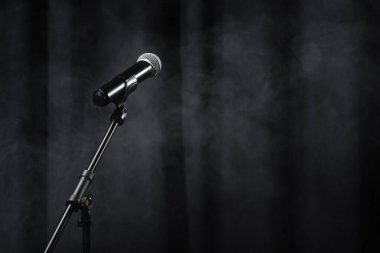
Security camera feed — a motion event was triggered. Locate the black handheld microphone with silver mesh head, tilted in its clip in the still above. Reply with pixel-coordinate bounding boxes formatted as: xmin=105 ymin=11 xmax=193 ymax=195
xmin=93 ymin=53 xmax=162 ymax=106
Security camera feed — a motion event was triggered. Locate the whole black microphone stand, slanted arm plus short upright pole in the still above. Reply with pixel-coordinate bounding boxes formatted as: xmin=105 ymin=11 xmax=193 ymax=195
xmin=44 ymin=103 xmax=127 ymax=253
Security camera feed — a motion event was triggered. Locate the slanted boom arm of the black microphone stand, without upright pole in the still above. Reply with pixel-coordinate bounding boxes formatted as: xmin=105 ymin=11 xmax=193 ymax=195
xmin=44 ymin=105 xmax=127 ymax=253
